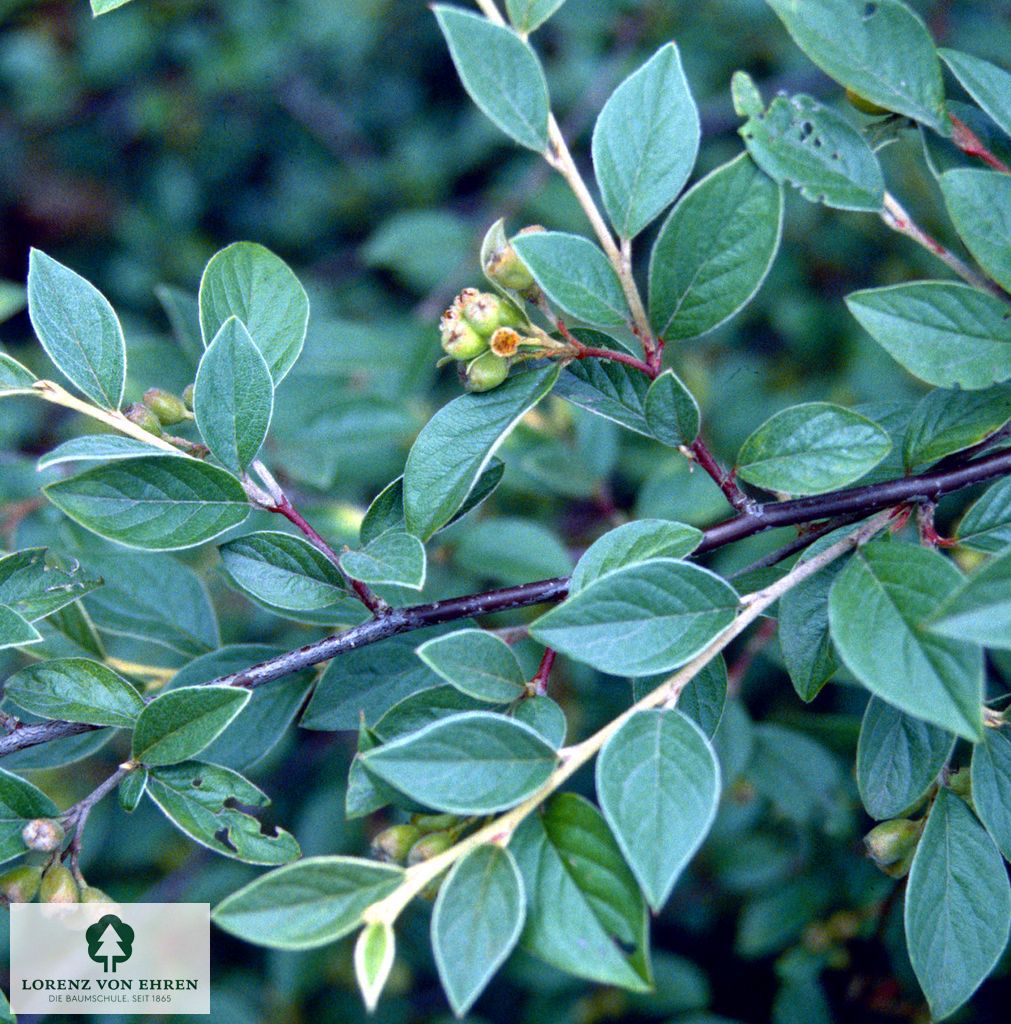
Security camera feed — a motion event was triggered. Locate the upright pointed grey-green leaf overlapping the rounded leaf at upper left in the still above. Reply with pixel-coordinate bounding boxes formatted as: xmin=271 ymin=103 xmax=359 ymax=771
xmin=194 ymin=316 xmax=273 ymax=473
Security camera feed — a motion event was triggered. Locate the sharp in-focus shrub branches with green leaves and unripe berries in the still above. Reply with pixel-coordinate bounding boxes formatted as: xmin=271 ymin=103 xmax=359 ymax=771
xmin=0 ymin=0 xmax=1011 ymax=1020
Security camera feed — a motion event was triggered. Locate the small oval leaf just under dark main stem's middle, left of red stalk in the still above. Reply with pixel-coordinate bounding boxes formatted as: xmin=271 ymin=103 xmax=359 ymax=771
xmin=417 ymin=630 xmax=526 ymax=703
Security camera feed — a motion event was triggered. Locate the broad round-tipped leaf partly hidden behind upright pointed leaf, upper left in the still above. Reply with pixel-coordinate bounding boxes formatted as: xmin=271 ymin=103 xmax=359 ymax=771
xmin=200 ymin=242 xmax=309 ymax=384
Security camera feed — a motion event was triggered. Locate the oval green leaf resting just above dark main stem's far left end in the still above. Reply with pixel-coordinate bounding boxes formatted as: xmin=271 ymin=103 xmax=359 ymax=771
xmin=4 ymin=657 xmax=144 ymax=728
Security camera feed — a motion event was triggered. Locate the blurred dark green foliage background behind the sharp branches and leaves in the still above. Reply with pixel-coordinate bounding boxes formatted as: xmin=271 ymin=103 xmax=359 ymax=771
xmin=0 ymin=0 xmax=1011 ymax=1024
